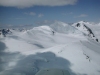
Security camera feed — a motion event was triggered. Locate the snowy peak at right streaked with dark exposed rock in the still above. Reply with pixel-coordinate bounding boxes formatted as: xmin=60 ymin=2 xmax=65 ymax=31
xmin=72 ymin=21 xmax=98 ymax=42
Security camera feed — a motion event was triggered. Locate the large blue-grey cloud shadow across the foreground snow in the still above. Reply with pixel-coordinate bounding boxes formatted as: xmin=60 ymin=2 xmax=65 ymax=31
xmin=0 ymin=42 xmax=86 ymax=75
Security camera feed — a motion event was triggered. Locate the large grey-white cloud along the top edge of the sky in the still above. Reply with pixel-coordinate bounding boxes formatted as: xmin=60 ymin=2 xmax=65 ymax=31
xmin=0 ymin=0 xmax=78 ymax=8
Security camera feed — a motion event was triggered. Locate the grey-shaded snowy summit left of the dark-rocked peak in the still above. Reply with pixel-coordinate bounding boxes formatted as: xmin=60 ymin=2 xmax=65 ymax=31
xmin=50 ymin=22 xmax=81 ymax=34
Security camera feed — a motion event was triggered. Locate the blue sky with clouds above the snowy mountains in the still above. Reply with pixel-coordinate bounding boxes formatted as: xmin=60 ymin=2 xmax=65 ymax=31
xmin=0 ymin=0 xmax=100 ymax=26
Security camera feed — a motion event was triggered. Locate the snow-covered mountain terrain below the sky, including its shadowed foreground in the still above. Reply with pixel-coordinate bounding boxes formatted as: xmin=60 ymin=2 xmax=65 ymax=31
xmin=0 ymin=21 xmax=100 ymax=75
